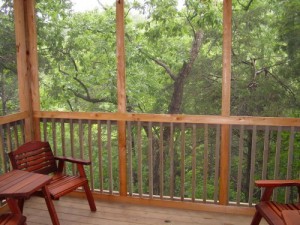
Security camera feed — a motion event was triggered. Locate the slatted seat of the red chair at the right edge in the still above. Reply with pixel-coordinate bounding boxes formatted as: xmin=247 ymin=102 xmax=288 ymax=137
xmin=255 ymin=201 xmax=300 ymax=225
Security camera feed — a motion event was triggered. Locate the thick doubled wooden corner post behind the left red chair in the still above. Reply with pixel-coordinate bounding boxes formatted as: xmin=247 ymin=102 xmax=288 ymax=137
xmin=14 ymin=0 xmax=40 ymax=141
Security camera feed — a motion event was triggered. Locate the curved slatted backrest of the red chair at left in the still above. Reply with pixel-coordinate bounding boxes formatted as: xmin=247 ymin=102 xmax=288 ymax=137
xmin=8 ymin=141 xmax=57 ymax=174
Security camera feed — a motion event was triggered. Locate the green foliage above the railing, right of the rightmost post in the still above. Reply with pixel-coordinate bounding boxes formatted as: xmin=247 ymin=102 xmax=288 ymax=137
xmin=232 ymin=0 xmax=299 ymax=116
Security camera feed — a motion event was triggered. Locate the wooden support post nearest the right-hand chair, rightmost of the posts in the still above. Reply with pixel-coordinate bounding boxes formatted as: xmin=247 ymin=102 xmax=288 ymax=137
xmin=219 ymin=0 xmax=232 ymax=205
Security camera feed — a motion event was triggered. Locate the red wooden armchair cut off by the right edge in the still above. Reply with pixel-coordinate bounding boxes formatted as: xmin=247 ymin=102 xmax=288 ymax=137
xmin=251 ymin=180 xmax=300 ymax=225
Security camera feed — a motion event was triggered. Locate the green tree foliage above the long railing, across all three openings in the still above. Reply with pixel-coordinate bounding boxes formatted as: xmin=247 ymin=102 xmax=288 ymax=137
xmin=37 ymin=0 xmax=299 ymax=116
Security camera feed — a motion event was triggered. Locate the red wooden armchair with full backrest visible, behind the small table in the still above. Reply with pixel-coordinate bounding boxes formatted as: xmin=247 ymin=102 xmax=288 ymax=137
xmin=8 ymin=141 xmax=97 ymax=211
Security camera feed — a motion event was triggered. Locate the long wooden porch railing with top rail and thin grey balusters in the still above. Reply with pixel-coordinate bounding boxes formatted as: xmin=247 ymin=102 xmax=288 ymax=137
xmin=1 ymin=112 xmax=300 ymax=206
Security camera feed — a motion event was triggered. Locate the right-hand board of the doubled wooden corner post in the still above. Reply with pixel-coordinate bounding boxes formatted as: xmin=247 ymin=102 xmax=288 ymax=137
xmin=25 ymin=0 xmax=41 ymax=140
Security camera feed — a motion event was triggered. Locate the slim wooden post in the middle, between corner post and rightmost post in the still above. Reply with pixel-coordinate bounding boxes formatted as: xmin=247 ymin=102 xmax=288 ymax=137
xmin=116 ymin=0 xmax=127 ymax=196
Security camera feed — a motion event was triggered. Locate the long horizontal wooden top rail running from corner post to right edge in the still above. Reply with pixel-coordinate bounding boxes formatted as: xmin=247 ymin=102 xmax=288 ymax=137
xmin=34 ymin=111 xmax=300 ymax=127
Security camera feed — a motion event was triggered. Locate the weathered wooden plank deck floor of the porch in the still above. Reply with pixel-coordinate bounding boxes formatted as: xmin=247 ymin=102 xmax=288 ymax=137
xmin=24 ymin=197 xmax=267 ymax=225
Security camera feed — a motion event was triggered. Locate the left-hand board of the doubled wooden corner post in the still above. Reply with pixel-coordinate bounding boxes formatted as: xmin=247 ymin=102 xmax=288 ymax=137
xmin=14 ymin=0 xmax=33 ymax=141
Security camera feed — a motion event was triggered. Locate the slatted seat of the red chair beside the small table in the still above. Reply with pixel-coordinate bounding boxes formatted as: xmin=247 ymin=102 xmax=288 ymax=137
xmin=48 ymin=175 xmax=88 ymax=199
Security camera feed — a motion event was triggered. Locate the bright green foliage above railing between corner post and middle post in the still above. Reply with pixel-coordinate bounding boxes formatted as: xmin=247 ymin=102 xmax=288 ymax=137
xmin=37 ymin=3 xmax=116 ymax=111
